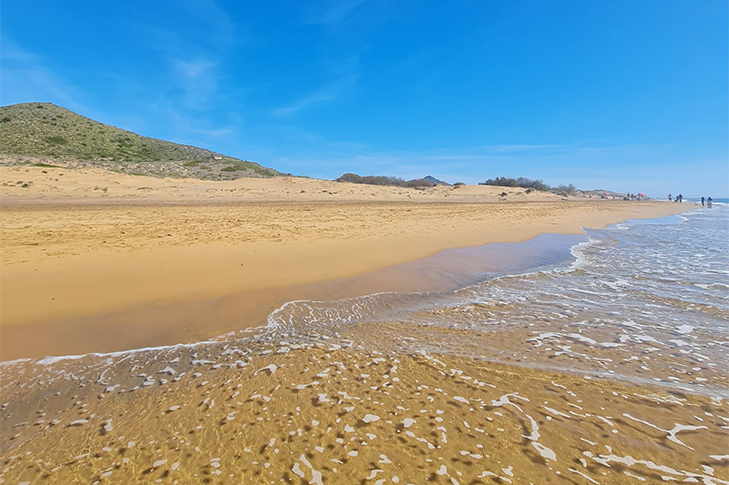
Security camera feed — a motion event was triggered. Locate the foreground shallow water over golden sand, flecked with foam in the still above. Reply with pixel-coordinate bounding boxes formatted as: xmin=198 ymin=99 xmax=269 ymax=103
xmin=0 ymin=335 xmax=729 ymax=484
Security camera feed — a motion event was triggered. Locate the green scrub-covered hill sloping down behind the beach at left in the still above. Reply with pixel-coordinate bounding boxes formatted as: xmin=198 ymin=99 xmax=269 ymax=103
xmin=0 ymin=103 xmax=280 ymax=179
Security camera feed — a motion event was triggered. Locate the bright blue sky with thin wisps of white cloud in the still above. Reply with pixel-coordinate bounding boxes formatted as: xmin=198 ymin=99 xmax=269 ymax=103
xmin=0 ymin=0 xmax=729 ymax=197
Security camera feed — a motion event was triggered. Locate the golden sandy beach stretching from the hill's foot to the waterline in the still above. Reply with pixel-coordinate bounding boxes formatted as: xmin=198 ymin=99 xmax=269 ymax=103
xmin=0 ymin=167 xmax=688 ymax=360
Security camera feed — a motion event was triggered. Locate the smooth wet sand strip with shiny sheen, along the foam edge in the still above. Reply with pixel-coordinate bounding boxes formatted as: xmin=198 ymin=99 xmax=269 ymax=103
xmin=2 ymin=234 xmax=586 ymax=359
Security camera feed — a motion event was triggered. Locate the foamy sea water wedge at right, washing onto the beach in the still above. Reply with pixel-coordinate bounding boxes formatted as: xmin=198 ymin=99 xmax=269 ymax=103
xmin=269 ymin=203 xmax=729 ymax=397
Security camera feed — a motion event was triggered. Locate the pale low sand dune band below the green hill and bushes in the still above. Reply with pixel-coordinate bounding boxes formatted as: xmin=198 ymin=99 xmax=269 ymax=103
xmin=0 ymin=166 xmax=561 ymax=205
